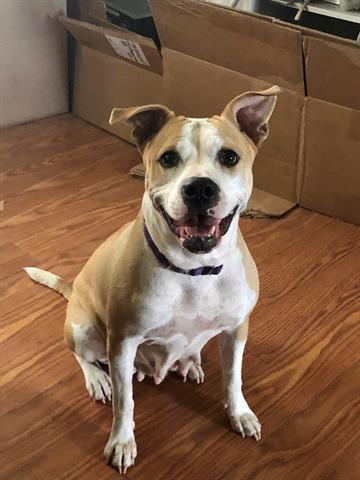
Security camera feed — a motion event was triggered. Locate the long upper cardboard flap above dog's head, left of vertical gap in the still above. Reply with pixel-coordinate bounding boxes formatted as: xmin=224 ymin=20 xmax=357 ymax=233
xmin=151 ymin=0 xmax=304 ymax=93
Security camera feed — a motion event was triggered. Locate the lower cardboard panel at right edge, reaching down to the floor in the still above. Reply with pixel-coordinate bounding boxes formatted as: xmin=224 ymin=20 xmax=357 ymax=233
xmin=299 ymin=98 xmax=360 ymax=224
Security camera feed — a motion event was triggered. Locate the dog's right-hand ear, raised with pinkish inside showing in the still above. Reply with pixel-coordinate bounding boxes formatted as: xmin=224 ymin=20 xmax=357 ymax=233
xmin=221 ymin=86 xmax=281 ymax=148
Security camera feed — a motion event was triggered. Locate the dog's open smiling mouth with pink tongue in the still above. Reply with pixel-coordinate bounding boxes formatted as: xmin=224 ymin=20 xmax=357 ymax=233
xmin=160 ymin=205 xmax=238 ymax=253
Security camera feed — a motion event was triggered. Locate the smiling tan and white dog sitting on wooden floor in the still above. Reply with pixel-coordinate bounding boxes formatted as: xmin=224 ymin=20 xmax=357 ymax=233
xmin=26 ymin=87 xmax=279 ymax=472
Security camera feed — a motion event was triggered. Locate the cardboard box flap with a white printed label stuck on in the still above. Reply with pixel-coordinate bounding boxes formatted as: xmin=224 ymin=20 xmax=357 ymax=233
xmin=59 ymin=15 xmax=162 ymax=74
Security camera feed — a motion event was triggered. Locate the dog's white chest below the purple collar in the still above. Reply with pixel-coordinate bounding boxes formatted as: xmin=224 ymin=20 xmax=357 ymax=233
xmin=142 ymin=251 xmax=256 ymax=347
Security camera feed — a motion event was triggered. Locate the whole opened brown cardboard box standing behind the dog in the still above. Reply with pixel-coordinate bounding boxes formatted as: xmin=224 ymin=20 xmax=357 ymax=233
xmin=61 ymin=0 xmax=360 ymax=224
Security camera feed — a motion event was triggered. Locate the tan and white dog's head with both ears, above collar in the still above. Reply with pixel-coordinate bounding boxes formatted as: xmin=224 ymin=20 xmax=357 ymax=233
xmin=110 ymin=87 xmax=280 ymax=253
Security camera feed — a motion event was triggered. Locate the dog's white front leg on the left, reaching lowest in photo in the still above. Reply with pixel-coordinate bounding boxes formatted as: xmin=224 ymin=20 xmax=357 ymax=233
xmin=104 ymin=337 xmax=139 ymax=473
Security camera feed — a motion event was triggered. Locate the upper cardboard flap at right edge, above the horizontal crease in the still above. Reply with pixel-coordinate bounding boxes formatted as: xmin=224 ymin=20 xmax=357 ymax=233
xmin=304 ymin=37 xmax=360 ymax=110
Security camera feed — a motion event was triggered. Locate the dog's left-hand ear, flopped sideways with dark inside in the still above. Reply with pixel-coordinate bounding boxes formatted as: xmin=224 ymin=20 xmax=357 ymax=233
xmin=109 ymin=105 xmax=174 ymax=150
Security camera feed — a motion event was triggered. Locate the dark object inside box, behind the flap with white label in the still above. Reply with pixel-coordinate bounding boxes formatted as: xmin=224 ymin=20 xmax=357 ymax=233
xmin=106 ymin=0 xmax=160 ymax=48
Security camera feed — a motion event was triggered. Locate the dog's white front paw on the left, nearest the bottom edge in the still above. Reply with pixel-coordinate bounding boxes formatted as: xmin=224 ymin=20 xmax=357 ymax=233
xmin=104 ymin=435 xmax=137 ymax=474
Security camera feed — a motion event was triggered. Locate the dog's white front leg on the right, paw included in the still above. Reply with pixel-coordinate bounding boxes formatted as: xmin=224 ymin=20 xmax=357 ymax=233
xmin=220 ymin=318 xmax=261 ymax=440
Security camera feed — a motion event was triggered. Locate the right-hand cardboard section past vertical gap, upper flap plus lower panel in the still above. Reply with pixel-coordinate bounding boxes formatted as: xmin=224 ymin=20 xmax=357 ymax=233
xmin=298 ymin=37 xmax=360 ymax=225
